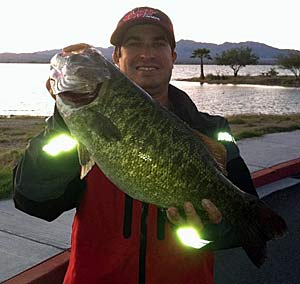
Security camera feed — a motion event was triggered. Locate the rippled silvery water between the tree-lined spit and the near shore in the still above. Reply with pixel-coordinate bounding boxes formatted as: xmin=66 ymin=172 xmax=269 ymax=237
xmin=172 ymin=81 xmax=300 ymax=116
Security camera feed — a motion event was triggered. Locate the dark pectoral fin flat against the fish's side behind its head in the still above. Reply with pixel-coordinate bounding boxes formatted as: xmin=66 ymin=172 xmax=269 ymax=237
xmin=88 ymin=111 xmax=122 ymax=142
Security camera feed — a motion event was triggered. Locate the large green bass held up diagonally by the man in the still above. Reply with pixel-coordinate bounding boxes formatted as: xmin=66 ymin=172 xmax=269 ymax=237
xmin=49 ymin=43 xmax=287 ymax=267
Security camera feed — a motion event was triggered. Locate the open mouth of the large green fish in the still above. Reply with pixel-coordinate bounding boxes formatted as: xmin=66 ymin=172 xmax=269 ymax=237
xmin=58 ymin=84 xmax=102 ymax=108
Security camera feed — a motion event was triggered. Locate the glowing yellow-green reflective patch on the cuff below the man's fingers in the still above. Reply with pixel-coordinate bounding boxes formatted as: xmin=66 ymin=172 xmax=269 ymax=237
xmin=176 ymin=227 xmax=210 ymax=249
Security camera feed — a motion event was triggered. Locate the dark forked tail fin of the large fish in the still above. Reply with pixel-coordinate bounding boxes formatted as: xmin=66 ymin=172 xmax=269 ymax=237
xmin=237 ymin=199 xmax=288 ymax=267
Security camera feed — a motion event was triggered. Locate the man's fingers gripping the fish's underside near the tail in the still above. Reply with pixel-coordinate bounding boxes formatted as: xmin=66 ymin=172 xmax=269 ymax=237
xmin=167 ymin=199 xmax=222 ymax=231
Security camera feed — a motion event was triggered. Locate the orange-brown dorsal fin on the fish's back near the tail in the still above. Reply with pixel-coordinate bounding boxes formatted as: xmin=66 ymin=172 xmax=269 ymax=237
xmin=195 ymin=130 xmax=227 ymax=176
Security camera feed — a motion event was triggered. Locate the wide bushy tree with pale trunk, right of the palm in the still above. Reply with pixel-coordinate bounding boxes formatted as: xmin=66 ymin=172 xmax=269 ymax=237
xmin=215 ymin=47 xmax=259 ymax=77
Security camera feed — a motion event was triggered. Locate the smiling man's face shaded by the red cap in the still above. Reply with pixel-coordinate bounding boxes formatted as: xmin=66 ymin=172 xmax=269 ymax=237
xmin=114 ymin=24 xmax=176 ymax=94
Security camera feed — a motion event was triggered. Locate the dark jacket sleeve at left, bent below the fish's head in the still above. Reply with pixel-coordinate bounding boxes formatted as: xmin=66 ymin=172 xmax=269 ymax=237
xmin=13 ymin=106 xmax=85 ymax=221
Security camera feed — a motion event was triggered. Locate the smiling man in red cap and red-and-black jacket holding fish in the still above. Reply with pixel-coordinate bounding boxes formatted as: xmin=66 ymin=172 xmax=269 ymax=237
xmin=14 ymin=7 xmax=256 ymax=284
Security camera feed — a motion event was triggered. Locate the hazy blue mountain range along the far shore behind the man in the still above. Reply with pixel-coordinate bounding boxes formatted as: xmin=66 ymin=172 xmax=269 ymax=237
xmin=0 ymin=39 xmax=293 ymax=64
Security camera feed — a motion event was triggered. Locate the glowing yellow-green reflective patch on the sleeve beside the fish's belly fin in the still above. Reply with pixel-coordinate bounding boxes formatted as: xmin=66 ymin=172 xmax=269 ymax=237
xmin=42 ymin=134 xmax=77 ymax=156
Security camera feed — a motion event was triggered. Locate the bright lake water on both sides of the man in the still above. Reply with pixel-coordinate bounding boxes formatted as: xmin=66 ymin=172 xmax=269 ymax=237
xmin=0 ymin=63 xmax=300 ymax=116
